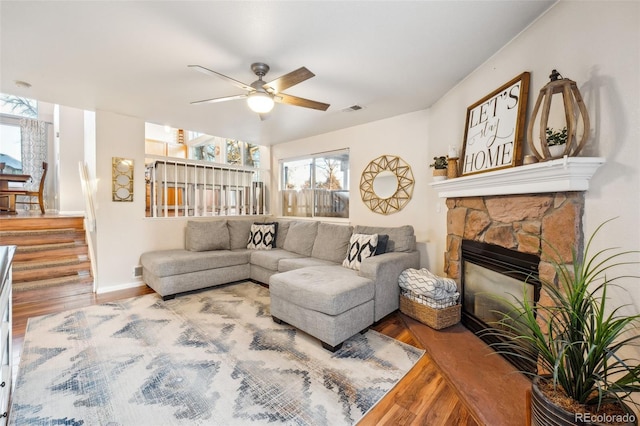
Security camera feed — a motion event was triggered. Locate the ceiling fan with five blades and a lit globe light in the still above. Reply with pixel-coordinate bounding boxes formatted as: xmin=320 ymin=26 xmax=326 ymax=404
xmin=189 ymin=62 xmax=330 ymax=120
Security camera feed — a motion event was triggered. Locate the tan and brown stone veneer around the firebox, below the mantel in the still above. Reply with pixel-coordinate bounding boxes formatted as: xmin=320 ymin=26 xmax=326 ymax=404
xmin=444 ymin=192 xmax=584 ymax=283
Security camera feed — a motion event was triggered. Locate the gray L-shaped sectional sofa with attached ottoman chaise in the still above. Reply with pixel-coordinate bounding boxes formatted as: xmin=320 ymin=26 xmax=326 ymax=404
xmin=140 ymin=217 xmax=420 ymax=351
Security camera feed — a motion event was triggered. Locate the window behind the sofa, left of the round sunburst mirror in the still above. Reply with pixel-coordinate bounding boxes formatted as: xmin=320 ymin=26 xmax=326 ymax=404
xmin=280 ymin=150 xmax=349 ymax=218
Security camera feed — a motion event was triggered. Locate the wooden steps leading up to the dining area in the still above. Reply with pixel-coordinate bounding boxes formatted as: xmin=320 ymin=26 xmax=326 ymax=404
xmin=0 ymin=216 xmax=93 ymax=302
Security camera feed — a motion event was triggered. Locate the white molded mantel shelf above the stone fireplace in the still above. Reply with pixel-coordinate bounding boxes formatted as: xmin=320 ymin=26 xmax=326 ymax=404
xmin=430 ymin=157 xmax=605 ymax=198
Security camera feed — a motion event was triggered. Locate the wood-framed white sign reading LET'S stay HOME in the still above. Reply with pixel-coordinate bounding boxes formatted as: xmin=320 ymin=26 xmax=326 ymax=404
xmin=460 ymin=72 xmax=530 ymax=176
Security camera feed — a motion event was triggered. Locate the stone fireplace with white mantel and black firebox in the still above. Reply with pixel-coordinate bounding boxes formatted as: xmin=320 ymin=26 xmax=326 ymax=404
xmin=431 ymin=157 xmax=604 ymax=370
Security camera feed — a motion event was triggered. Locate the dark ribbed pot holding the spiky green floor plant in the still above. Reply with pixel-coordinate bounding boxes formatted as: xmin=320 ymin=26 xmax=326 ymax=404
xmin=531 ymin=377 xmax=638 ymax=426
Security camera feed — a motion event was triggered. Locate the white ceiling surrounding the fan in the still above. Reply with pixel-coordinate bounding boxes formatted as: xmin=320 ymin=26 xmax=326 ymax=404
xmin=0 ymin=0 xmax=555 ymax=145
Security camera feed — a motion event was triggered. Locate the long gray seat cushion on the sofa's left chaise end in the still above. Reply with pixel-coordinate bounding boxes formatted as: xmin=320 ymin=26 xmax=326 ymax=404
xmin=140 ymin=249 xmax=251 ymax=277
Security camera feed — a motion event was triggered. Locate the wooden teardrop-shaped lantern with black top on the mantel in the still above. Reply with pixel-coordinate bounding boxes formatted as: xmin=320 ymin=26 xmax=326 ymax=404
xmin=527 ymin=70 xmax=589 ymax=161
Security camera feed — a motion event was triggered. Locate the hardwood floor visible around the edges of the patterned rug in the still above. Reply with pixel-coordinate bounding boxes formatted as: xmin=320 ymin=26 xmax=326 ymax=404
xmin=13 ymin=286 xmax=479 ymax=426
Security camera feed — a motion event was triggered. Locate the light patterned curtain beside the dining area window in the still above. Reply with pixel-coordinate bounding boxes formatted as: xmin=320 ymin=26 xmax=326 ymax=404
xmin=20 ymin=118 xmax=48 ymax=191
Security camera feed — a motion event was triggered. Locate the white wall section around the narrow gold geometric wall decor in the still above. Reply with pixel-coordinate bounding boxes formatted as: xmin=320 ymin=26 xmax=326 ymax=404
xmin=95 ymin=111 xmax=185 ymax=292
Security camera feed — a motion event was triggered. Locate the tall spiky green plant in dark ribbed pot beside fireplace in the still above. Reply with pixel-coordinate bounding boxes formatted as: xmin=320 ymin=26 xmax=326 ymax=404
xmin=491 ymin=219 xmax=640 ymax=426
